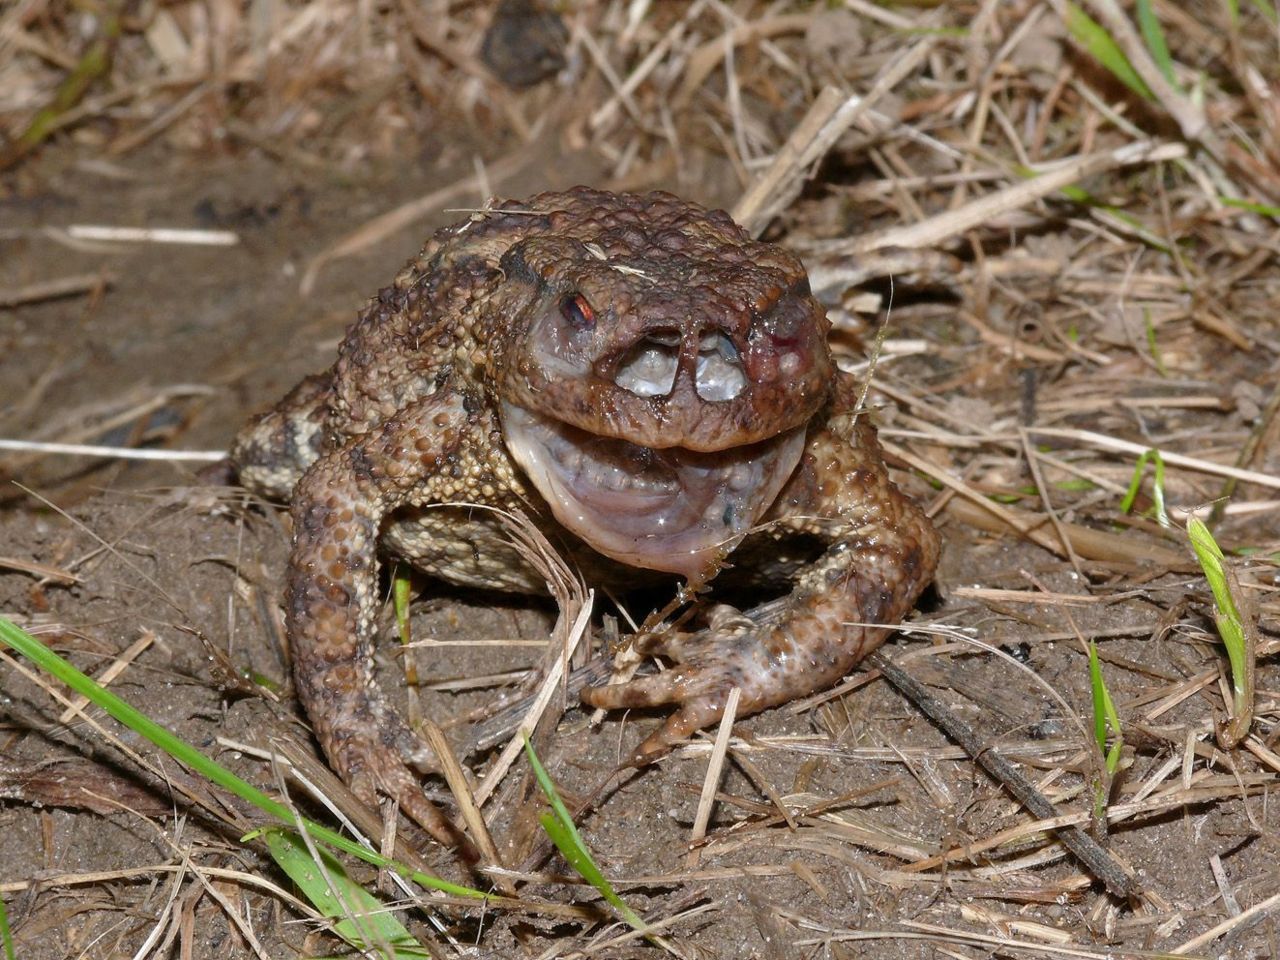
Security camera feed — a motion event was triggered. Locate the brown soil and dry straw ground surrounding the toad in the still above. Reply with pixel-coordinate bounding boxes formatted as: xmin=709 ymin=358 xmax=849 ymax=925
xmin=0 ymin=0 xmax=1280 ymax=960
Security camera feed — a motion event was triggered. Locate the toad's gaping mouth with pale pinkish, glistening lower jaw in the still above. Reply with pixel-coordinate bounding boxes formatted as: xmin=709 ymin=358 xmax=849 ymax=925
xmin=502 ymin=403 xmax=805 ymax=580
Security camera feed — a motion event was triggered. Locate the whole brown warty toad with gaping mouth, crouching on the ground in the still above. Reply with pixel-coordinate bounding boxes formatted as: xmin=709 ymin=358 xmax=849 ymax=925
xmin=232 ymin=188 xmax=938 ymax=842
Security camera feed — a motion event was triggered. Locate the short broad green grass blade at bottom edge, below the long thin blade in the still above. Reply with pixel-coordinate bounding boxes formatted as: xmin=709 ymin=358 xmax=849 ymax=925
xmin=262 ymin=827 xmax=431 ymax=960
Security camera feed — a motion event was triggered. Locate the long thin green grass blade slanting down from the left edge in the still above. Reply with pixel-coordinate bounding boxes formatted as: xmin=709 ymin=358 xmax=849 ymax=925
xmin=0 ymin=617 xmax=486 ymax=899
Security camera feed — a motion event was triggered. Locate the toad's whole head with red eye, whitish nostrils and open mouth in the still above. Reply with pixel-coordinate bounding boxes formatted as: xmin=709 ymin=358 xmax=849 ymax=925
xmin=489 ymin=191 xmax=833 ymax=579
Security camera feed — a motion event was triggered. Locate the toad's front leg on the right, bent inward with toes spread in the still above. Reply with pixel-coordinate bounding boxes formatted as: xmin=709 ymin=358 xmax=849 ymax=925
xmin=582 ymin=415 xmax=938 ymax=763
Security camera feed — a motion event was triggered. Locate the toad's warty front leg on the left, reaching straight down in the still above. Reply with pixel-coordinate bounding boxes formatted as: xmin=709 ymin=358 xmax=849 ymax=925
xmin=285 ymin=390 xmax=480 ymax=847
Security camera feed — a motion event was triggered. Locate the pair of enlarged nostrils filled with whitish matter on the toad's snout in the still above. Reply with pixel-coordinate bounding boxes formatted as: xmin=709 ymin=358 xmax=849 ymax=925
xmin=612 ymin=328 xmax=746 ymax=402
